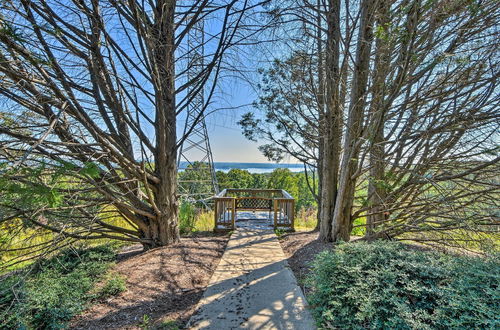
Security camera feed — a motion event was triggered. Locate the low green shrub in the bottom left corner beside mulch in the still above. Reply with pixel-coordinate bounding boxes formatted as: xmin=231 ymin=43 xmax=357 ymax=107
xmin=0 ymin=245 xmax=118 ymax=329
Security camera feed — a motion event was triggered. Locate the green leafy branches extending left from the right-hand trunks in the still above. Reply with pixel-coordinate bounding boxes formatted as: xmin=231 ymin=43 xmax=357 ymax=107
xmin=238 ymin=50 xmax=320 ymax=162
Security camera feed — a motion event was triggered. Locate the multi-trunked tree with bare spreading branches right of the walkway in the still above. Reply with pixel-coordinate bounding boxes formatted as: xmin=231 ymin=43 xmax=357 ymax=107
xmin=240 ymin=0 xmax=500 ymax=248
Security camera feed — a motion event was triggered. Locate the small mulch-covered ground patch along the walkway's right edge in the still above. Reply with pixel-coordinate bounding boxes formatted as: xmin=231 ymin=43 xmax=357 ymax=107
xmin=279 ymin=231 xmax=333 ymax=294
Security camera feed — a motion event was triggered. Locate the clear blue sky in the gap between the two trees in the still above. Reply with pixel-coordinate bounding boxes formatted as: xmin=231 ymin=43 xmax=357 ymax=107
xmin=177 ymin=3 xmax=297 ymax=163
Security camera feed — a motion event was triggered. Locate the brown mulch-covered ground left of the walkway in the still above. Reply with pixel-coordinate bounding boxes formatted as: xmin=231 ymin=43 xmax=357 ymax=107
xmin=71 ymin=236 xmax=228 ymax=329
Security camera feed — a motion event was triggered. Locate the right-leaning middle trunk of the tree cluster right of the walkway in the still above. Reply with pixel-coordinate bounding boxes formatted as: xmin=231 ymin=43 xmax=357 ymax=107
xmin=331 ymin=0 xmax=377 ymax=241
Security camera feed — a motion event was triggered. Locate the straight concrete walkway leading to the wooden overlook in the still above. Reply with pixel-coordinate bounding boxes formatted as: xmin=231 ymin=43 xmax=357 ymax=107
xmin=188 ymin=215 xmax=315 ymax=330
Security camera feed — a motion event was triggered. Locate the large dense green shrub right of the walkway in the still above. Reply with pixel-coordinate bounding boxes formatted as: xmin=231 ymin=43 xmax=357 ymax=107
xmin=306 ymin=242 xmax=500 ymax=329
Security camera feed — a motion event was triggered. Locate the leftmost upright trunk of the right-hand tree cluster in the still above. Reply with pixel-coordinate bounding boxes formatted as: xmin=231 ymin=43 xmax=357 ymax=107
xmin=319 ymin=0 xmax=342 ymax=241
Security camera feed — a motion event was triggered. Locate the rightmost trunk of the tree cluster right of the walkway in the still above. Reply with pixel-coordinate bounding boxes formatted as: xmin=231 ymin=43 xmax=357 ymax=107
xmin=366 ymin=0 xmax=391 ymax=239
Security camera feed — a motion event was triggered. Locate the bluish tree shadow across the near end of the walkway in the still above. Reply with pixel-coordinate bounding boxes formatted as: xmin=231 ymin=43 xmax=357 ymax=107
xmin=189 ymin=261 xmax=313 ymax=330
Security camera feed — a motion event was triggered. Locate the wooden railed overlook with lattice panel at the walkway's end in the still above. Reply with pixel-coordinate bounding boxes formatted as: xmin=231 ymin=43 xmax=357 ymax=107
xmin=213 ymin=189 xmax=295 ymax=231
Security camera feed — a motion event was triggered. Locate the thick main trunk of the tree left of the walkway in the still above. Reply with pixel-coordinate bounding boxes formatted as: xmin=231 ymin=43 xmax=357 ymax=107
xmin=145 ymin=0 xmax=179 ymax=247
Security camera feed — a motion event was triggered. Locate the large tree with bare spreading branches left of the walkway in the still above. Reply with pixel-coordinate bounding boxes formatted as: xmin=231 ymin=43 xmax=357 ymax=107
xmin=0 ymin=0 xmax=268 ymax=262
